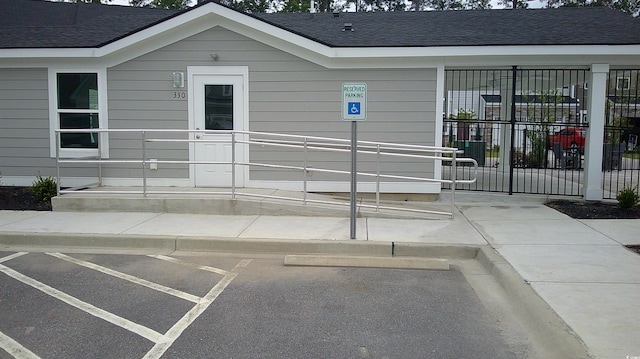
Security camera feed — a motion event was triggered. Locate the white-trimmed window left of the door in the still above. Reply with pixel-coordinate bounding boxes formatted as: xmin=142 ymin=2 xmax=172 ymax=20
xmin=49 ymin=71 xmax=107 ymax=157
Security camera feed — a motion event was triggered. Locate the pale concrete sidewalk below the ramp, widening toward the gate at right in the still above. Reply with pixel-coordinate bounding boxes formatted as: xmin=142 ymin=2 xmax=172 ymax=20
xmin=0 ymin=193 xmax=640 ymax=359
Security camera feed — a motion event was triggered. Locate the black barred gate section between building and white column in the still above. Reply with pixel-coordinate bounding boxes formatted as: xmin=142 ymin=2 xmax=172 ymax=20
xmin=442 ymin=67 xmax=588 ymax=196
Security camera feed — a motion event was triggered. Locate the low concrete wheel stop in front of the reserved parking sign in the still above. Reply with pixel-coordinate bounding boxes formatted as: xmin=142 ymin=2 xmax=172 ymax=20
xmin=284 ymin=255 xmax=449 ymax=270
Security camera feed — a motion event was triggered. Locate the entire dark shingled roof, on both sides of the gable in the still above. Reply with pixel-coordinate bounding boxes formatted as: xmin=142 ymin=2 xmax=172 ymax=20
xmin=0 ymin=0 xmax=640 ymax=49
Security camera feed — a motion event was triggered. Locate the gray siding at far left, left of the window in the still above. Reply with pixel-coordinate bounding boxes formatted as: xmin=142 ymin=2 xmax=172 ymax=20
xmin=0 ymin=69 xmax=56 ymax=177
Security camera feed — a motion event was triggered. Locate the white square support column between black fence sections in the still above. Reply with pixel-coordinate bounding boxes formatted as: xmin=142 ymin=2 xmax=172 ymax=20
xmin=584 ymin=64 xmax=609 ymax=201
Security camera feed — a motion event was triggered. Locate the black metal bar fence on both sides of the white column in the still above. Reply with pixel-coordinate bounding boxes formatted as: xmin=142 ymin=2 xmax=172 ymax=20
xmin=442 ymin=67 xmax=640 ymax=198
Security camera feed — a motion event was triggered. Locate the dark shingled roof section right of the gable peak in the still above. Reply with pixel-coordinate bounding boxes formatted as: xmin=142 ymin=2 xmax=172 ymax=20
xmin=255 ymin=7 xmax=640 ymax=47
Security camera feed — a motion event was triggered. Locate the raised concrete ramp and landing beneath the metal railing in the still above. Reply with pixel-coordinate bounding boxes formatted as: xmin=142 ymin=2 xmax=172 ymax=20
xmin=52 ymin=187 xmax=450 ymax=219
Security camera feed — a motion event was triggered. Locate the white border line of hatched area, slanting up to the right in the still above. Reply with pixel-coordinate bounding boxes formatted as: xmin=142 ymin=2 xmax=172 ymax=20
xmin=143 ymin=259 xmax=251 ymax=359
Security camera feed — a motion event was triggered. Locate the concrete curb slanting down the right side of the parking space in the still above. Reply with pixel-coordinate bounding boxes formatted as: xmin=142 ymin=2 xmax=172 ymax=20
xmin=476 ymin=246 xmax=593 ymax=358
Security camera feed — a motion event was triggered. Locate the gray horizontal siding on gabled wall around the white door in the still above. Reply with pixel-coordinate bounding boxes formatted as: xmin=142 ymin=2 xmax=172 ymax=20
xmin=105 ymin=28 xmax=436 ymax=181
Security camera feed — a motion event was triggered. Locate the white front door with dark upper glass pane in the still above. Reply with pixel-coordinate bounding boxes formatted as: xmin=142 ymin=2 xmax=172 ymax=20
xmin=191 ymin=74 xmax=245 ymax=187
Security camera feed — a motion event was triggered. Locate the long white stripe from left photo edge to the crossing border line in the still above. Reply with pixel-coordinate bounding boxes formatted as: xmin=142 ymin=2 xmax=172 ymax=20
xmin=0 ymin=264 xmax=163 ymax=343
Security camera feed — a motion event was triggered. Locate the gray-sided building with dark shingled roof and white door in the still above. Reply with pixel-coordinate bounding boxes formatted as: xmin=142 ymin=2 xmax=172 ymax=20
xmin=0 ymin=0 xmax=640 ymax=197
